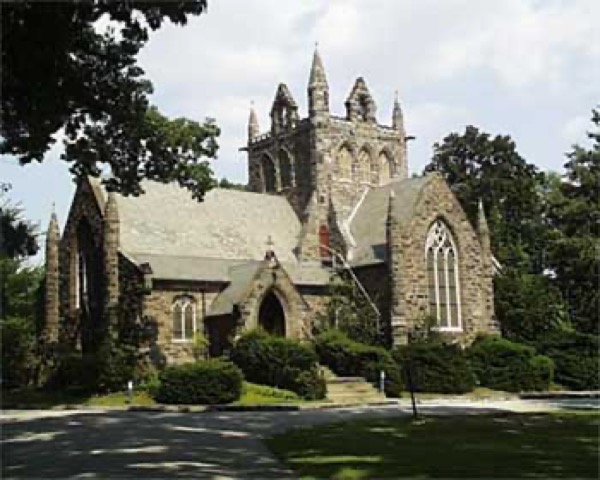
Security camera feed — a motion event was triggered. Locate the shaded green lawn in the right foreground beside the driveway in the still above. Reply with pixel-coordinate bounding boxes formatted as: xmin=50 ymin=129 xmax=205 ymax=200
xmin=267 ymin=413 xmax=600 ymax=479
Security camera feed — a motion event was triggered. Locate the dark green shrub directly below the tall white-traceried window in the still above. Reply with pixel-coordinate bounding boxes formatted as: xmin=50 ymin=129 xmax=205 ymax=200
xmin=393 ymin=342 xmax=475 ymax=393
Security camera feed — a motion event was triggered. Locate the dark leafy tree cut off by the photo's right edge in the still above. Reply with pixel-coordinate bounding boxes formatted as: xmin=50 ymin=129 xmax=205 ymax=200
xmin=546 ymin=110 xmax=600 ymax=334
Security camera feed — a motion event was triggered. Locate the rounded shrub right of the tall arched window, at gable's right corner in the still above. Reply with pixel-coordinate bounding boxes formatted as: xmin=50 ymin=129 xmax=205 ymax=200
xmin=468 ymin=336 xmax=553 ymax=392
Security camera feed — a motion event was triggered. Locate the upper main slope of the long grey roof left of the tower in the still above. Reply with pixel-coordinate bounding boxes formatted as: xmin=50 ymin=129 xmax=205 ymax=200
xmin=110 ymin=182 xmax=300 ymax=261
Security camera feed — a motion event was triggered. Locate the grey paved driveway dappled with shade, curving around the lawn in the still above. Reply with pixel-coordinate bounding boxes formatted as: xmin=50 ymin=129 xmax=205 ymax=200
xmin=1 ymin=402 xmax=596 ymax=478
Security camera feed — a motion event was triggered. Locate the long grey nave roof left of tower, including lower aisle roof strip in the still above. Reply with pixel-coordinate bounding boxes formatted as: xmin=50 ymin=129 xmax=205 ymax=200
xmin=90 ymin=178 xmax=329 ymax=286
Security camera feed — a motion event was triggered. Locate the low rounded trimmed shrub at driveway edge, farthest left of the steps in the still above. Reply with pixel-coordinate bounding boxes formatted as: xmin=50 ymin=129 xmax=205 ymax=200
xmin=155 ymin=360 xmax=243 ymax=405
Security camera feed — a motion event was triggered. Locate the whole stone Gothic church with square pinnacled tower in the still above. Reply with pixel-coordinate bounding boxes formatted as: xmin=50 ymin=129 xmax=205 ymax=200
xmin=46 ymin=52 xmax=496 ymax=362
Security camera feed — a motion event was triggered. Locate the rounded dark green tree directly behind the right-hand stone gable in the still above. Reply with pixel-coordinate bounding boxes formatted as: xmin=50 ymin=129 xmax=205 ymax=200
xmin=425 ymin=126 xmax=545 ymax=271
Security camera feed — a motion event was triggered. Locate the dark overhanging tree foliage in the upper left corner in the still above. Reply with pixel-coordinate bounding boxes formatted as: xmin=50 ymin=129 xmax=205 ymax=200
xmin=0 ymin=0 xmax=219 ymax=199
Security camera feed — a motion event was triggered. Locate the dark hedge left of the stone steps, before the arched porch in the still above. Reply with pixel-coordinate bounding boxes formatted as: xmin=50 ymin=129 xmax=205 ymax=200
xmin=231 ymin=330 xmax=326 ymax=400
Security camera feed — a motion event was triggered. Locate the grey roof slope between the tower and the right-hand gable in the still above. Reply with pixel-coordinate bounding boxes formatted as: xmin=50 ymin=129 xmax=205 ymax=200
xmin=350 ymin=176 xmax=432 ymax=265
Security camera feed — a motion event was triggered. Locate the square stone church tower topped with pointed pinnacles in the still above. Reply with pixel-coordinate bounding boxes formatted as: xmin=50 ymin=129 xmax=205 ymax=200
xmin=245 ymin=49 xmax=407 ymax=261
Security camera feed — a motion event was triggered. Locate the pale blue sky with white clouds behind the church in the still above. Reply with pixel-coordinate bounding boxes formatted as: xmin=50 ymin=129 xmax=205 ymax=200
xmin=0 ymin=0 xmax=600 ymax=260
